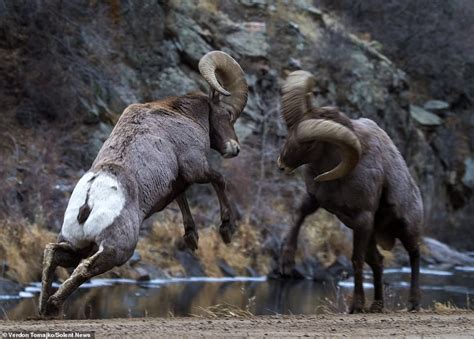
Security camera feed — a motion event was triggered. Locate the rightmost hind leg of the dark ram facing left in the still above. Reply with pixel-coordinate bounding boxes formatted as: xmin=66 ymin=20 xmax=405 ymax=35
xmin=400 ymin=230 xmax=421 ymax=311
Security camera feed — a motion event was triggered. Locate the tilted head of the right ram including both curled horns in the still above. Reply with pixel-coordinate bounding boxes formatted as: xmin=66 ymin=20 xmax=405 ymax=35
xmin=278 ymin=71 xmax=361 ymax=181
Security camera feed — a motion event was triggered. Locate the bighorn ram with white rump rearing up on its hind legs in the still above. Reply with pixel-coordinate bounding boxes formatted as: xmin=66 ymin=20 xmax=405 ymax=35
xmin=39 ymin=51 xmax=248 ymax=315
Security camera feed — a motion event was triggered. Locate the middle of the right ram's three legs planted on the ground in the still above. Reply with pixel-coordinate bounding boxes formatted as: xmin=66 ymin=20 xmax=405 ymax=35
xmin=365 ymin=236 xmax=384 ymax=313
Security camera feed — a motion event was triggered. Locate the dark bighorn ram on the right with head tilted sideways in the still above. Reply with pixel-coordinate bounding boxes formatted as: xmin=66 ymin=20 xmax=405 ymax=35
xmin=278 ymin=71 xmax=423 ymax=312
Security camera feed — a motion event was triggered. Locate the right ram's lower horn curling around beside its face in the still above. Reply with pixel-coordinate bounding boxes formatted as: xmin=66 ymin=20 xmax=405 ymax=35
xmin=296 ymin=119 xmax=362 ymax=181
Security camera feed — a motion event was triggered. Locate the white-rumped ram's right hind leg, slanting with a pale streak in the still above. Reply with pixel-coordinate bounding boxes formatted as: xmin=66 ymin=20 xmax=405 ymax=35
xmin=44 ymin=245 xmax=133 ymax=315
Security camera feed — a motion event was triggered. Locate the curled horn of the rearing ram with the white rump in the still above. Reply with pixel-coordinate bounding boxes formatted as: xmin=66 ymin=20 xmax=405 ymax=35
xmin=199 ymin=51 xmax=248 ymax=122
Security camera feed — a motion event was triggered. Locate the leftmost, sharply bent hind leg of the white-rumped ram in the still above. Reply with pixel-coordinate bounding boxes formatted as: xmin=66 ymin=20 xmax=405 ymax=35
xmin=39 ymin=242 xmax=82 ymax=314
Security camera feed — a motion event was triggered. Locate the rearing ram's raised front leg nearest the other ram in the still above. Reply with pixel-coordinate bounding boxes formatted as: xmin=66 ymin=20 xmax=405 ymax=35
xmin=196 ymin=168 xmax=236 ymax=244
